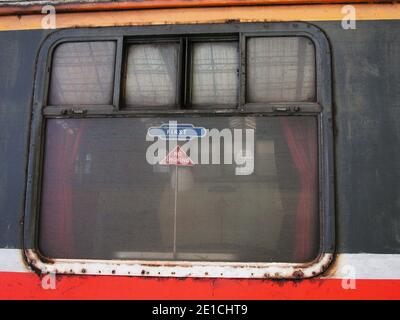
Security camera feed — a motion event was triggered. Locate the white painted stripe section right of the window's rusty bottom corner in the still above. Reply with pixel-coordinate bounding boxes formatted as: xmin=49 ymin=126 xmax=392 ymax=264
xmin=327 ymin=253 xmax=400 ymax=280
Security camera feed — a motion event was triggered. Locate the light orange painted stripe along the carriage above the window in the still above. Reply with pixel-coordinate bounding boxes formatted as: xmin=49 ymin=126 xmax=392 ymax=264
xmin=0 ymin=4 xmax=400 ymax=30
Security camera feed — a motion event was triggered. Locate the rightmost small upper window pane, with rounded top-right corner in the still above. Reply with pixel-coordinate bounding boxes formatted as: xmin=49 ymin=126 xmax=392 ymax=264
xmin=246 ymin=37 xmax=315 ymax=102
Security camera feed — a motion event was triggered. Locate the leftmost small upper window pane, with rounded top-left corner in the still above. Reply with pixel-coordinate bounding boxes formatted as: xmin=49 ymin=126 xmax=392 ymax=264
xmin=48 ymin=41 xmax=116 ymax=106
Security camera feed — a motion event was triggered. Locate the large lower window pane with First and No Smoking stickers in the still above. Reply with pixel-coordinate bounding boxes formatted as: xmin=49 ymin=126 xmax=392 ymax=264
xmin=40 ymin=116 xmax=319 ymax=262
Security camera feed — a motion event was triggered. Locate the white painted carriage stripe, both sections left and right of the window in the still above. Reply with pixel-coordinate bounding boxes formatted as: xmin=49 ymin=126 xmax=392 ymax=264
xmin=0 ymin=249 xmax=400 ymax=280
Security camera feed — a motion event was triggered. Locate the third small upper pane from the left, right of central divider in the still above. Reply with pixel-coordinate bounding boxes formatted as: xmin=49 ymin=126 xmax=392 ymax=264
xmin=191 ymin=42 xmax=239 ymax=105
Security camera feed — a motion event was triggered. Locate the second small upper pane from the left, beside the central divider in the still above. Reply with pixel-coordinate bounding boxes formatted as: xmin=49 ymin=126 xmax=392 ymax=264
xmin=125 ymin=44 xmax=179 ymax=107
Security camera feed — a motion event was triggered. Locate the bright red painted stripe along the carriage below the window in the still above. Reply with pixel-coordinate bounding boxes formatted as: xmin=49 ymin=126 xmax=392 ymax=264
xmin=0 ymin=272 xmax=400 ymax=300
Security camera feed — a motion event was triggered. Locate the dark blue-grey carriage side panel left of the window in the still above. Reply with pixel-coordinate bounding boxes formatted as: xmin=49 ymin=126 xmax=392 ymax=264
xmin=0 ymin=31 xmax=45 ymax=248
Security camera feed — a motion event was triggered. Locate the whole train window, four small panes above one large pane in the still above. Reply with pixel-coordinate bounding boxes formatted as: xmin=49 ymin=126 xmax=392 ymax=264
xmin=29 ymin=26 xmax=327 ymax=277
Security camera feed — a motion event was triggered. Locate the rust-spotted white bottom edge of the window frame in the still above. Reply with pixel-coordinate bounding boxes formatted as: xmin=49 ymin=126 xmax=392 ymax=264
xmin=25 ymin=249 xmax=334 ymax=279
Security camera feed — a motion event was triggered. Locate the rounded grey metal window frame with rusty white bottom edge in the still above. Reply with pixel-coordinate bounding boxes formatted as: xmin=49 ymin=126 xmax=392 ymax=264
xmin=23 ymin=23 xmax=335 ymax=279
